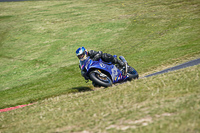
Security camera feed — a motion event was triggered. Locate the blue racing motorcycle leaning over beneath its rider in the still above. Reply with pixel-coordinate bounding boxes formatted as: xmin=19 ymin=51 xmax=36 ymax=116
xmin=80 ymin=55 xmax=139 ymax=87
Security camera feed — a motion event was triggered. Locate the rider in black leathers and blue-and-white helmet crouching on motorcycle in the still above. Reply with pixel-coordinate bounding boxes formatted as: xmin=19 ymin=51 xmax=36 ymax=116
xmin=76 ymin=47 xmax=126 ymax=75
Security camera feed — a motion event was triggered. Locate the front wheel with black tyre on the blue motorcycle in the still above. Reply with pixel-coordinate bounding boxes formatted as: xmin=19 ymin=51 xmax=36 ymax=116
xmin=89 ymin=70 xmax=112 ymax=87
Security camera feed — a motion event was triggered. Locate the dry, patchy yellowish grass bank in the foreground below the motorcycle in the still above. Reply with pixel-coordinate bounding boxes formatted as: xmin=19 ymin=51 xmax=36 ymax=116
xmin=0 ymin=66 xmax=200 ymax=132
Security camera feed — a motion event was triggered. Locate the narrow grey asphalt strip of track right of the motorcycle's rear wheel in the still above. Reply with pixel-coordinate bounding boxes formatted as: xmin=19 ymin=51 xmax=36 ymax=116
xmin=141 ymin=58 xmax=200 ymax=78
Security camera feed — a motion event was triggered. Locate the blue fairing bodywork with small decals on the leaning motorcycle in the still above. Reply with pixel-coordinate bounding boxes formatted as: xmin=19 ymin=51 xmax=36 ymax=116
xmin=80 ymin=57 xmax=128 ymax=83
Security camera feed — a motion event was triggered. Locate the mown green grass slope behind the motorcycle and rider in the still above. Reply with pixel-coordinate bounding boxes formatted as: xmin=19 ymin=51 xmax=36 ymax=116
xmin=0 ymin=0 xmax=200 ymax=115
